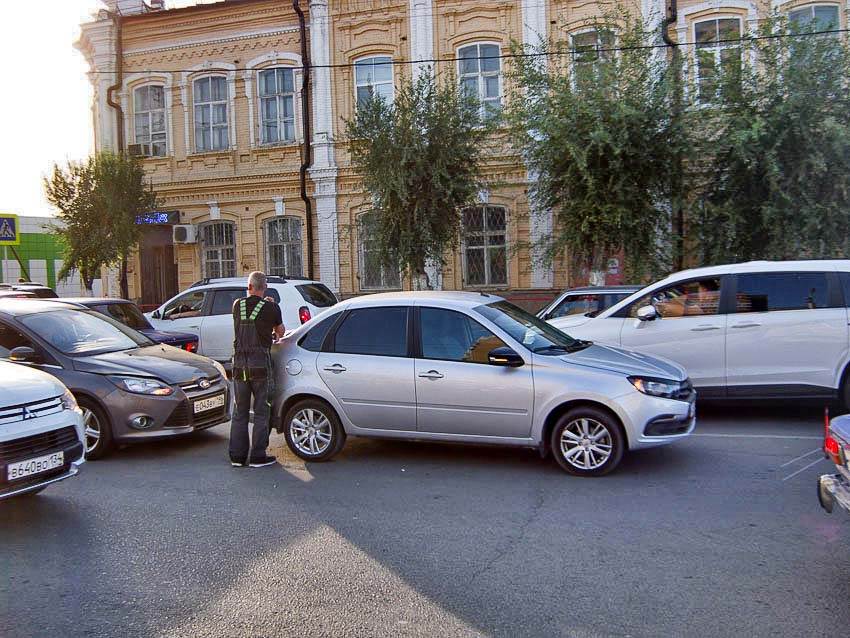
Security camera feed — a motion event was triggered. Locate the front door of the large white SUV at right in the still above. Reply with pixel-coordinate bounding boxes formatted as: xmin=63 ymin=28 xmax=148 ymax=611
xmin=620 ymin=277 xmax=726 ymax=396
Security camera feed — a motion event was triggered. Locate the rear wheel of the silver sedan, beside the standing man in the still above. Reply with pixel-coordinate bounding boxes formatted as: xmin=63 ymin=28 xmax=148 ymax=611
xmin=283 ymin=399 xmax=345 ymax=461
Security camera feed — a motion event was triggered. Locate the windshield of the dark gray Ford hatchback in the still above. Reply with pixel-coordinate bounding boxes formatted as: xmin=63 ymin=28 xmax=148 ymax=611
xmin=21 ymin=310 xmax=153 ymax=356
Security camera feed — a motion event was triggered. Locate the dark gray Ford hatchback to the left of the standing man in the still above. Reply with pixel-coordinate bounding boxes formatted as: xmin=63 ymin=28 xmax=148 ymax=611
xmin=0 ymin=299 xmax=230 ymax=459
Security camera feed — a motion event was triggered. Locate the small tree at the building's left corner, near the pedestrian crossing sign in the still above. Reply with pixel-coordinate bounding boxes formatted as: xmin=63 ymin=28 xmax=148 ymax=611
xmin=44 ymin=152 xmax=156 ymax=297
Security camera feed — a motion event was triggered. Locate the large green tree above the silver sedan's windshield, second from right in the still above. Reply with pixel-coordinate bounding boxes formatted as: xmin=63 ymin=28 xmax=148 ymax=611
xmin=507 ymin=11 xmax=691 ymax=278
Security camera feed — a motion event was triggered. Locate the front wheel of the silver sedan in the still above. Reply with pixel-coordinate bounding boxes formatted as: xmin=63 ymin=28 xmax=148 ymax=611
xmin=550 ymin=406 xmax=626 ymax=476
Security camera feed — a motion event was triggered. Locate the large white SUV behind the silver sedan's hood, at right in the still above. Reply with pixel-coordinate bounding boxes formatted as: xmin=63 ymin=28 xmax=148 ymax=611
xmin=550 ymin=260 xmax=850 ymax=406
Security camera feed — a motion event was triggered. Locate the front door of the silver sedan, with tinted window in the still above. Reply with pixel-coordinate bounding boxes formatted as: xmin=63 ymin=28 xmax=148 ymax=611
xmin=416 ymin=308 xmax=534 ymax=438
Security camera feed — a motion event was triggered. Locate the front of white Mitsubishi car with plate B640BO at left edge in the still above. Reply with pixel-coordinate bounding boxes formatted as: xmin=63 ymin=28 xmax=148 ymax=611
xmin=0 ymin=361 xmax=85 ymax=499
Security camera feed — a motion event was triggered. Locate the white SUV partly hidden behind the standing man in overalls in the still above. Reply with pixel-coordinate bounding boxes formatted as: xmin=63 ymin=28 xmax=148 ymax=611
xmin=145 ymin=276 xmax=337 ymax=362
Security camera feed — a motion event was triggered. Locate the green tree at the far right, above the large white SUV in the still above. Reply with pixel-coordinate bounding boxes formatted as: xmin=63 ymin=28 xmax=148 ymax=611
xmin=693 ymin=18 xmax=850 ymax=263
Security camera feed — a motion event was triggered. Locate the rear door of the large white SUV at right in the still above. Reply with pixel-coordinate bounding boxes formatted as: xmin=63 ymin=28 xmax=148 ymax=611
xmin=726 ymin=272 xmax=848 ymax=396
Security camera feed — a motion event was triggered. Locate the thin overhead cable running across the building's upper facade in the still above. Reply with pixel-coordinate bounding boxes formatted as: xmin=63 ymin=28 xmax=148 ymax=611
xmin=81 ymin=29 xmax=850 ymax=75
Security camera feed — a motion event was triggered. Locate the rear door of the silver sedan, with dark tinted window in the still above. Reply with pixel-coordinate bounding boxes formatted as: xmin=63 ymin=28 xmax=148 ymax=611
xmin=317 ymin=307 xmax=416 ymax=432
